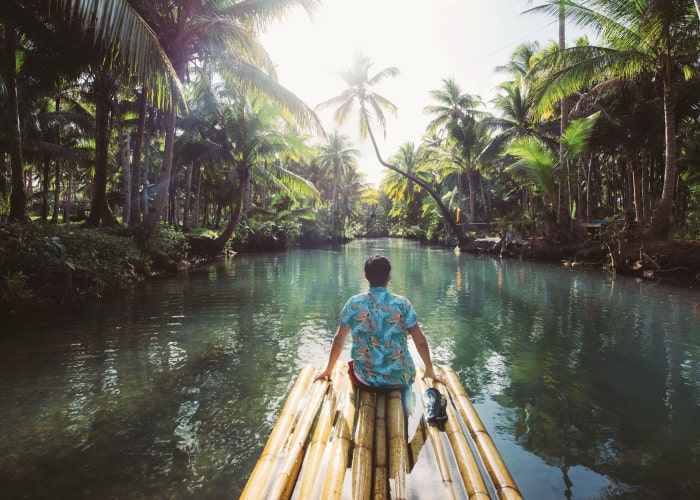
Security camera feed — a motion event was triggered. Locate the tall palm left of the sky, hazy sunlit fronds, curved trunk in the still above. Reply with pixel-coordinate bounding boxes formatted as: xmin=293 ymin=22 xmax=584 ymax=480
xmin=139 ymin=0 xmax=321 ymax=234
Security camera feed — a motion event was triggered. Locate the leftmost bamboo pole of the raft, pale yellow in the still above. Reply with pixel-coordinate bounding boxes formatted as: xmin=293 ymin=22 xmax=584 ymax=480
xmin=241 ymin=366 xmax=315 ymax=499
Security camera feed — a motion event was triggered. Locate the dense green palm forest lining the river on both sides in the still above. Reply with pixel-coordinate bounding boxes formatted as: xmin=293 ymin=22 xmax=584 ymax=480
xmin=0 ymin=0 xmax=700 ymax=312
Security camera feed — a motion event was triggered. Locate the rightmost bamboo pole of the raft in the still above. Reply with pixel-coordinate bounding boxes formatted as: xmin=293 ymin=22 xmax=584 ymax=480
xmin=443 ymin=367 xmax=522 ymax=500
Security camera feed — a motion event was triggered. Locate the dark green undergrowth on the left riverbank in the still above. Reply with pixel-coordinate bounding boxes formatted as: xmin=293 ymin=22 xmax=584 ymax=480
xmin=0 ymin=223 xmax=187 ymax=315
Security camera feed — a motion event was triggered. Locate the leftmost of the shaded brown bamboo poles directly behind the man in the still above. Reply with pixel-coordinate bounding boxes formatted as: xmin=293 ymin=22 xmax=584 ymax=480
xmin=352 ymin=390 xmax=375 ymax=499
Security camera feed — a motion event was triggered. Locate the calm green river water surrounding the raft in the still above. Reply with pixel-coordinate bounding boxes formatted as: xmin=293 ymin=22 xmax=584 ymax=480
xmin=0 ymin=240 xmax=700 ymax=499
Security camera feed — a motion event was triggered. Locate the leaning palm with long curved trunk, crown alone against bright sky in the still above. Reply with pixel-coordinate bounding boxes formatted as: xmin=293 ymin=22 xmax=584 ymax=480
xmin=317 ymin=53 xmax=465 ymax=244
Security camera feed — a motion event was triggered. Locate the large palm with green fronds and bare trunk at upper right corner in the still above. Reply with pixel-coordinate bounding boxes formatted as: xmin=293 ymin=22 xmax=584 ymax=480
xmin=532 ymin=0 xmax=700 ymax=238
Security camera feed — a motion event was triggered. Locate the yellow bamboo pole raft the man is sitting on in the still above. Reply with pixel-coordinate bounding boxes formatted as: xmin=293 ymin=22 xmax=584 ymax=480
xmin=241 ymin=363 xmax=522 ymax=500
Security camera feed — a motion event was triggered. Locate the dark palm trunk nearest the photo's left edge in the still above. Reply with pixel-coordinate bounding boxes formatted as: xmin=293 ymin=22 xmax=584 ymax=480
xmin=5 ymin=16 xmax=29 ymax=222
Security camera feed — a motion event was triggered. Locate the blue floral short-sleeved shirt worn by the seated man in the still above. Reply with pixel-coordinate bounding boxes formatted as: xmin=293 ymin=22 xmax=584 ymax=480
xmin=340 ymin=287 xmax=417 ymax=387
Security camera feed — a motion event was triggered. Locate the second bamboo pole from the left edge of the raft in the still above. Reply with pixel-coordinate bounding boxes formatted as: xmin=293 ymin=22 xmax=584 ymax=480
xmin=267 ymin=380 xmax=328 ymax=499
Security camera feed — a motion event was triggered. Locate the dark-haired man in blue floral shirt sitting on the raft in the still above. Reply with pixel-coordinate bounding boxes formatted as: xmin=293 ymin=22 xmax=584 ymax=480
xmin=314 ymin=255 xmax=444 ymax=391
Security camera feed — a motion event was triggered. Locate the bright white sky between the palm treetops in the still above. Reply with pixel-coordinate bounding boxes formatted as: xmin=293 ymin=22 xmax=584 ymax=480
xmin=262 ymin=0 xmax=580 ymax=185
